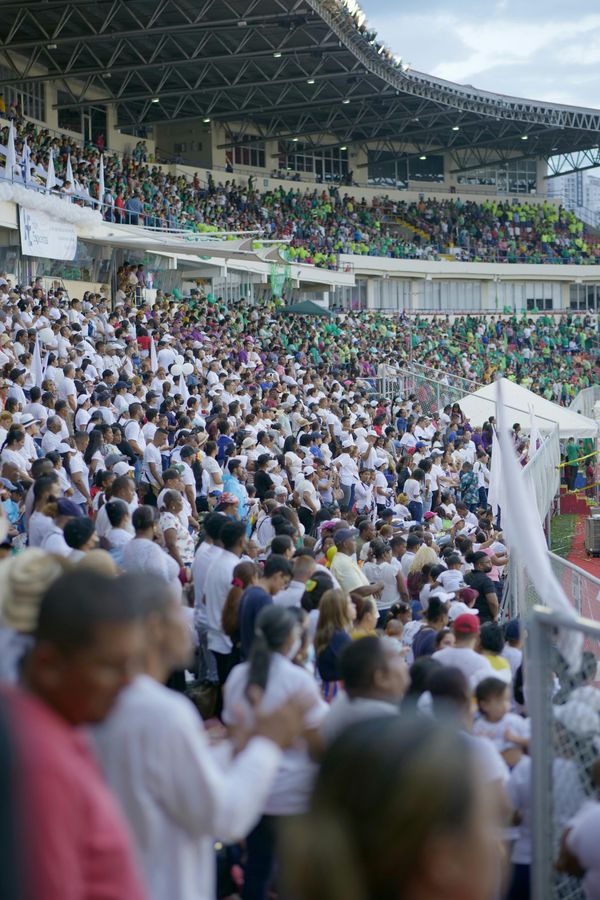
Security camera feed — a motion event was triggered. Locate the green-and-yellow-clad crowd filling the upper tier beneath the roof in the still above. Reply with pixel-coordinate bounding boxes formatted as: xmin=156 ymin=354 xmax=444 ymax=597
xmin=0 ymin=121 xmax=600 ymax=268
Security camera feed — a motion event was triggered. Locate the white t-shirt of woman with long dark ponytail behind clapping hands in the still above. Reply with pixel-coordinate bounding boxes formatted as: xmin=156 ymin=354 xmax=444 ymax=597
xmin=223 ymin=653 xmax=329 ymax=816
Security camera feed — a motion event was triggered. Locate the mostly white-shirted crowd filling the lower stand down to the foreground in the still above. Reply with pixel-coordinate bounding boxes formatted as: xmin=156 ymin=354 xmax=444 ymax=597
xmin=0 ymin=280 xmax=600 ymax=900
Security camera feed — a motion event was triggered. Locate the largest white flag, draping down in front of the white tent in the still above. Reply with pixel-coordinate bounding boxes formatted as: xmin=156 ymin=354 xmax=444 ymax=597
xmin=496 ymin=379 xmax=583 ymax=670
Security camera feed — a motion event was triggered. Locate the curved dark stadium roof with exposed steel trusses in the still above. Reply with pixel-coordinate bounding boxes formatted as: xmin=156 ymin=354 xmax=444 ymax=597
xmin=0 ymin=0 xmax=600 ymax=174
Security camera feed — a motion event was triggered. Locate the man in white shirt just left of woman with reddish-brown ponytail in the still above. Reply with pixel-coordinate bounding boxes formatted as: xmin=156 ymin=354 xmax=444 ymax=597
xmin=204 ymin=522 xmax=246 ymax=684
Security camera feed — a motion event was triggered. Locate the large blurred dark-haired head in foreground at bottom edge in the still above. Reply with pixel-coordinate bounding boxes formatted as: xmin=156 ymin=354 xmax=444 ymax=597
xmin=282 ymin=716 xmax=500 ymax=900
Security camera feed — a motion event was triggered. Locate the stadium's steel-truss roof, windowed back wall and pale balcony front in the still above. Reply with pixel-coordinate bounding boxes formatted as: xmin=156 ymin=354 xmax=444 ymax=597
xmin=0 ymin=0 xmax=600 ymax=312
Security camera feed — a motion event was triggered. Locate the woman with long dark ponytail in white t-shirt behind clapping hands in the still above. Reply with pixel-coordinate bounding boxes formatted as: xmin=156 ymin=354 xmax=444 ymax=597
xmin=223 ymin=604 xmax=327 ymax=900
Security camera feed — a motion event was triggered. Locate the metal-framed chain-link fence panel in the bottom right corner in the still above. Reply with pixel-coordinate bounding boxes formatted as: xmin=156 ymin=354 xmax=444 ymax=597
xmin=528 ymin=606 xmax=600 ymax=900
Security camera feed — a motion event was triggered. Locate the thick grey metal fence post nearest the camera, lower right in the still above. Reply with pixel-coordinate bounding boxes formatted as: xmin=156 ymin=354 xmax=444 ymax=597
xmin=526 ymin=607 xmax=554 ymax=900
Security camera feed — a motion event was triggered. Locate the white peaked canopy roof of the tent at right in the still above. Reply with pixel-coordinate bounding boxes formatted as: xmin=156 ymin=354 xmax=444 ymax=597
xmin=459 ymin=378 xmax=598 ymax=440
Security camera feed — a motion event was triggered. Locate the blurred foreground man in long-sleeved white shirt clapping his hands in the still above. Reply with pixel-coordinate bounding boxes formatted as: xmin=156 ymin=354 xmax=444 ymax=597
xmin=92 ymin=576 xmax=306 ymax=900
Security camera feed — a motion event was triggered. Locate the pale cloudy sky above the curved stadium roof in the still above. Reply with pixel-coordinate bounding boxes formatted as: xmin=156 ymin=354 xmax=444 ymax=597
xmin=360 ymin=0 xmax=600 ymax=108
